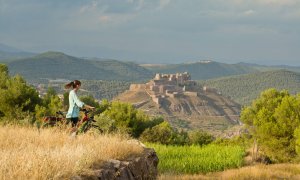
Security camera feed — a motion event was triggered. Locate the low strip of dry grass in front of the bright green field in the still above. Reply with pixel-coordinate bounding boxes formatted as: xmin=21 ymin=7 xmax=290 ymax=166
xmin=159 ymin=164 xmax=300 ymax=180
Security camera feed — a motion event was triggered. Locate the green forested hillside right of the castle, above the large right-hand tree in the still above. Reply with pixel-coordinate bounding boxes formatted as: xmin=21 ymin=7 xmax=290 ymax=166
xmin=199 ymin=70 xmax=300 ymax=105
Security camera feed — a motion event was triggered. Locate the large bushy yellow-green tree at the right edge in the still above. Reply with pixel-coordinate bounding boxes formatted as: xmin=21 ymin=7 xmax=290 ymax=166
xmin=241 ymin=89 xmax=300 ymax=162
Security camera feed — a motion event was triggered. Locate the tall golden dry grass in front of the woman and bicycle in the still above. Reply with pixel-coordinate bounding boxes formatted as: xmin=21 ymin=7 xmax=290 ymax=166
xmin=0 ymin=127 xmax=142 ymax=179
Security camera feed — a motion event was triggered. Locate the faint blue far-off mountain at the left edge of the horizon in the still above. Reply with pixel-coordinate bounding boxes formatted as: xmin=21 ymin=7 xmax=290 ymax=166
xmin=0 ymin=43 xmax=34 ymax=62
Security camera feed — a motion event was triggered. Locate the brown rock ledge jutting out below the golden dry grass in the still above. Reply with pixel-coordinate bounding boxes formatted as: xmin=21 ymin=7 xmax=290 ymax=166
xmin=73 ymin=148 xmax=158 ymax=180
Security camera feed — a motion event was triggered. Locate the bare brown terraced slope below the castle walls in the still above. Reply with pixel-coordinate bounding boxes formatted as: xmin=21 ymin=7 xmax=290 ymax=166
xmin=115 ymin=90 xmax=241 ymax=134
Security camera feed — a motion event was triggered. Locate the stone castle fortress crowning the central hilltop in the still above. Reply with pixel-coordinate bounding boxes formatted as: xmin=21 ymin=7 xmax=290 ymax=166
xmin=129 ymin=72 xmax=198 ymax=104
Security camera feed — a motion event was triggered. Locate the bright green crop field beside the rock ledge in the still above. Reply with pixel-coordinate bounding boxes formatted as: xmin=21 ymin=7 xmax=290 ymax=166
xmin=147 ymin=144 xmax=245 ymax=174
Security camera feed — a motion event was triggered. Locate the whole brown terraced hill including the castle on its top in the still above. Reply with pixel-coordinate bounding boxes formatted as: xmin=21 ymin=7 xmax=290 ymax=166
xmin=115 ymin=73 xmax=241 ymax=135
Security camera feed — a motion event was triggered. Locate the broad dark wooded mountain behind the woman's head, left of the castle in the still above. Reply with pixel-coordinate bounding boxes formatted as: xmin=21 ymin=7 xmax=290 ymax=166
xmin=6 ymin=52 xmax=152 ymax=81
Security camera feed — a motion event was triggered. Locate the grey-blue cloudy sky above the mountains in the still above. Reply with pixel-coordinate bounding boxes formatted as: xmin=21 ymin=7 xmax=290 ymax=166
xmin=0 ymin=0 xmax=300 ymax=66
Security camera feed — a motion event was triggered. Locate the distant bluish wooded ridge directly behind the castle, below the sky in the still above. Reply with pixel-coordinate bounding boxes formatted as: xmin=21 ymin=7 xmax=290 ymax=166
xmin=143 ymin=61 xmax=259 ymax=80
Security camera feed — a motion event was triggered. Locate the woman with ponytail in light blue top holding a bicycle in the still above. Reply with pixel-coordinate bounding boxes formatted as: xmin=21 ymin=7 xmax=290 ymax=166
xmin=65 ymin=80 xmax=94 ymax=127
